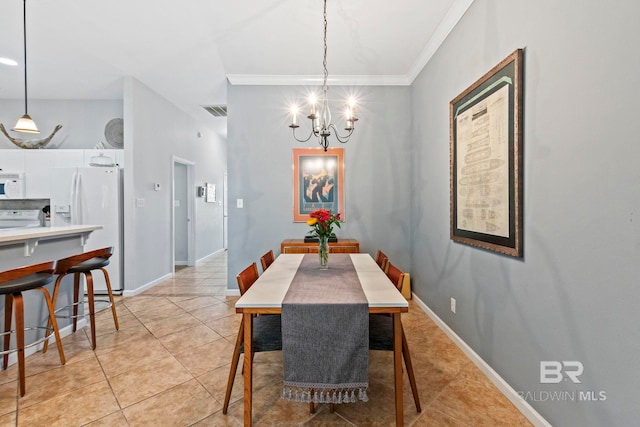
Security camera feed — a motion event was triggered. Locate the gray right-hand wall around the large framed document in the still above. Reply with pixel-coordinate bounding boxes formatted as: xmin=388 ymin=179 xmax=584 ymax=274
xmin=411 ymin=0 xmax=640 ymax=426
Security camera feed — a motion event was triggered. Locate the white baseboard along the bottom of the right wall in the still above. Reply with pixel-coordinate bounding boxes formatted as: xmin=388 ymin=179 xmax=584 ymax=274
xmin=412 ymin=294 xmax=551 ymax=427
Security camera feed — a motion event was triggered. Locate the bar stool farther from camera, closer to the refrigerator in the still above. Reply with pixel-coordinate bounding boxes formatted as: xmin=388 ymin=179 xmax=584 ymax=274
xmin=44 ymin=247 xmax=120 ymax=351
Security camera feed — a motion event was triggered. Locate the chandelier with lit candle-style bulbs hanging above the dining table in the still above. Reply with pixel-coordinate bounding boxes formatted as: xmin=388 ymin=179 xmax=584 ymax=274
xmin=289 ymin=0 xmax=358 ymax=151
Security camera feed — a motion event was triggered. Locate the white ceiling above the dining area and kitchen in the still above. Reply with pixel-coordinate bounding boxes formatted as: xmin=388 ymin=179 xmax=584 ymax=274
xmin=0 ymin=0 xmax=473 ymax=117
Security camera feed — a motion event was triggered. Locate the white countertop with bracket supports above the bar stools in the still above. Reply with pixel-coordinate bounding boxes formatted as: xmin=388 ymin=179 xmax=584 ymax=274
xmin=0 ymin=225 xmax=102 ymax=256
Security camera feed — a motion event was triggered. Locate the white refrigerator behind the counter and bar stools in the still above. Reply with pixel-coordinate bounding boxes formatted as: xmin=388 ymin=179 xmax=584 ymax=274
xmin=49 ymin=166 xmax=124 ymax=294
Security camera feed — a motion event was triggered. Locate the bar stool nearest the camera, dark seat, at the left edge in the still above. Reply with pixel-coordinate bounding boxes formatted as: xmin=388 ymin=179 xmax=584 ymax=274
xmin=0 ymin=261 xmax=65 ymax=396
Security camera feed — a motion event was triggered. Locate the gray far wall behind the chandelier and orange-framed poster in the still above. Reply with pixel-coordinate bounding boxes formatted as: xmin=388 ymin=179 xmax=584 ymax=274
xmin=228 ymin=85 xmax=411 ymax=289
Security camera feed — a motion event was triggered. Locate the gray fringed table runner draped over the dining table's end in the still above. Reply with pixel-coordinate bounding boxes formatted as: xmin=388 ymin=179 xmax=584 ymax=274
xmin=282 ymin=254 xmax=369 ymax=403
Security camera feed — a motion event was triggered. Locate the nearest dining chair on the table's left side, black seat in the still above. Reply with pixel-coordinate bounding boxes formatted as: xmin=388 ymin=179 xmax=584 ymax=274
xmin=222 ymin=262 xmax=282 ymax=414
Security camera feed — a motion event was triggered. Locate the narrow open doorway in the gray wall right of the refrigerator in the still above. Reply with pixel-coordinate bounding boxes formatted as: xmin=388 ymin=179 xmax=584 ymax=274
xmin=171 ymin=157 xmax=195 ymax=273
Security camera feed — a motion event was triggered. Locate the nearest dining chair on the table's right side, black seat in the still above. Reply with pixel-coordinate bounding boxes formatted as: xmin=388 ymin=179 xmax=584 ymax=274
xmin=369 ymin=262 xmax=422 ymax=412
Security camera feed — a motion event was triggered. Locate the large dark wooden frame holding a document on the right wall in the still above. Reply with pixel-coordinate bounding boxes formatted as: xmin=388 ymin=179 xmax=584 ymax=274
xmin=449 ymin=49 xmax=524 ymax=258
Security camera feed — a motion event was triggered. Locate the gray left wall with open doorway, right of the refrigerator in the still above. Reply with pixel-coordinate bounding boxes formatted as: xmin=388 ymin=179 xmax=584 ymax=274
xmin=124 ymin=77 xmax=226 ymax=295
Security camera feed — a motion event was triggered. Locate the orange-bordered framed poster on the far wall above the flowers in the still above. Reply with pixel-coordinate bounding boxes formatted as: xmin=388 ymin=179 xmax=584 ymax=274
xmin=292 ymin=147 xmax=346 ymax=222
